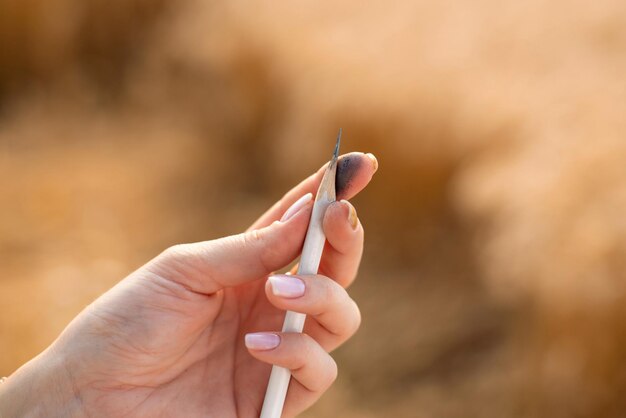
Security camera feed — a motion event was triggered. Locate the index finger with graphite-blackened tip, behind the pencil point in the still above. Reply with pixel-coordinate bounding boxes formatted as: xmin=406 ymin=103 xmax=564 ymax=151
xmin=250 ymin=152 xmax=378 ymax=229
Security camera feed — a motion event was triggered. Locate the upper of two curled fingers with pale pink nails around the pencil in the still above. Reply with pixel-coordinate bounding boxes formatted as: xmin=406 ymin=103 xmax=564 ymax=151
xmin=265 ymin=275 xmax=361 ymax=351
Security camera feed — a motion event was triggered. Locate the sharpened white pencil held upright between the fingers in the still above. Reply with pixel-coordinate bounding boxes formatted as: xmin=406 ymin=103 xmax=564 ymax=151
xmin=260 ymin=129 xmax=341 ymax=418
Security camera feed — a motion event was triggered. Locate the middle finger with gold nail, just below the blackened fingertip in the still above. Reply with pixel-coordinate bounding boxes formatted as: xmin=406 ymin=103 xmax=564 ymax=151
xmin=319 ymin=200 xmax=364 ymax=287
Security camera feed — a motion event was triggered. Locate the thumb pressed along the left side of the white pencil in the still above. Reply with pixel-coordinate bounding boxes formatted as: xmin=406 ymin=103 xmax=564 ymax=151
xmin=147 ymin=193 xmax=313 ymax=294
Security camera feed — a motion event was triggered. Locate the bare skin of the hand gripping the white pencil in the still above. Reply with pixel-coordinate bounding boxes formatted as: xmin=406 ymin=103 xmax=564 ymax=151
xmin=0 ymin=153 xmax=377 ymax=417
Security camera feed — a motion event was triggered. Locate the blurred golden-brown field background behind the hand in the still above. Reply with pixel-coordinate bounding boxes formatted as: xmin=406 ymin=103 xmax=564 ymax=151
xmin=0 ymin=0 xmax=626 ymax=418
